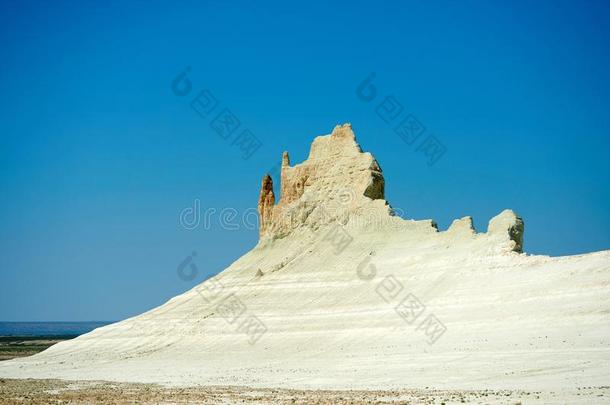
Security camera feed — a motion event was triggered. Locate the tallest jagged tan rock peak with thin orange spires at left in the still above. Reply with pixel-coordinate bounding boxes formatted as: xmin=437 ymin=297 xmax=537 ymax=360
xmin=258 ymin=124 xmax=385 ymax=237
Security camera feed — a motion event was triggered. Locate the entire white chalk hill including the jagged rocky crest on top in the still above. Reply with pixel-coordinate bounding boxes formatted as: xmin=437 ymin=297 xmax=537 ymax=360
xmin=0 ymin=124 xmax=610 ymax=389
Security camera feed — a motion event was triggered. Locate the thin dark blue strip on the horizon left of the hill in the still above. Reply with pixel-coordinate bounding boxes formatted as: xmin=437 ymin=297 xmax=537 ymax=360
xmin=0 ymin=321 xmax=113 ymax=336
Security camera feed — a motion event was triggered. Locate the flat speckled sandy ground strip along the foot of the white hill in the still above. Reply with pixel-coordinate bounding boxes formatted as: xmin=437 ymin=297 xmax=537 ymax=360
xmin=0 ymin=379 xmax=610 ymax=405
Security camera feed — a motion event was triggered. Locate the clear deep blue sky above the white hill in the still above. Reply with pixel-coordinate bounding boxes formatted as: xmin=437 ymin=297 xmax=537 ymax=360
xmin=0 ymin=1 xmax=610 ymax=321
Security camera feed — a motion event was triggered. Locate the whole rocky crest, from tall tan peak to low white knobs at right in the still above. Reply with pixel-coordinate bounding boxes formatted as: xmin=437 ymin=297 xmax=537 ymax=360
xmin=258 ymin=124 xmax=524 ymax=252
